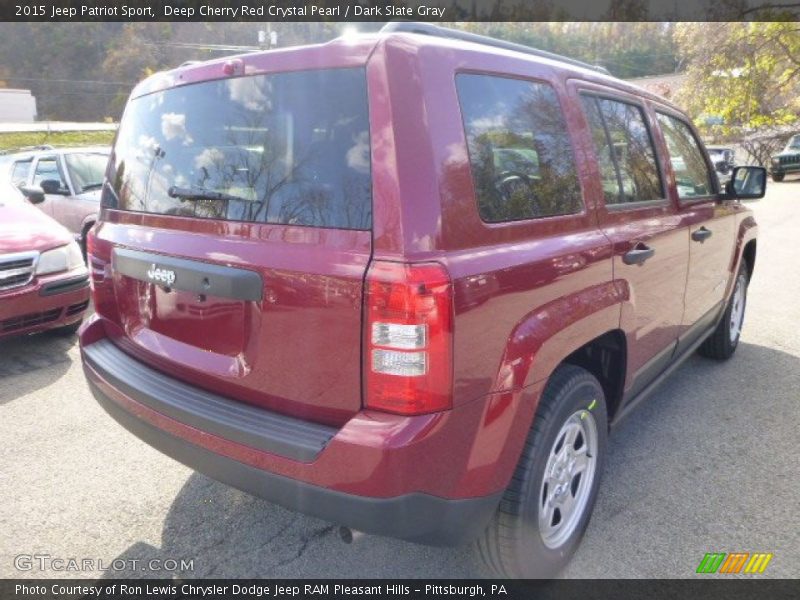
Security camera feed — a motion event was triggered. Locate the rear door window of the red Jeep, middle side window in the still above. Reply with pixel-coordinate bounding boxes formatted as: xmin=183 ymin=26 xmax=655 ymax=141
xmin=583 ymin=96 xmax=664 ymax=204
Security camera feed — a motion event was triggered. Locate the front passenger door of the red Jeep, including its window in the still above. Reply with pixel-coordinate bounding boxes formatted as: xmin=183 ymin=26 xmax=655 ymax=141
xmin=656 ymin=109 xmax=738 ymax=351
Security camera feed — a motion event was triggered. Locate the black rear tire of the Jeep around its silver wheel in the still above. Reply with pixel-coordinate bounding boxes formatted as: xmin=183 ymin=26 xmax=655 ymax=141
xmin=476 ymin=365 xmax=608 ymax=578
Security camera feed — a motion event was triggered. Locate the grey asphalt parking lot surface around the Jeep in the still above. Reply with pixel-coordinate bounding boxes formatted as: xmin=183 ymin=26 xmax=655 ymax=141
xmin=0 ymin=180 xmax=800 ymax=578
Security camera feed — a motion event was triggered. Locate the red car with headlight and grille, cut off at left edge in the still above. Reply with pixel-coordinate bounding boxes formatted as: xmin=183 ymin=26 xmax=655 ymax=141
xmin=0 ymin=184 xmax=89 ymax=338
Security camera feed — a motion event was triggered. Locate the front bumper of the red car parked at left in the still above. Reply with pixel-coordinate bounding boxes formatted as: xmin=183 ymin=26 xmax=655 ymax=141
xmin=0 ymin=269 xmax=89 ymax=337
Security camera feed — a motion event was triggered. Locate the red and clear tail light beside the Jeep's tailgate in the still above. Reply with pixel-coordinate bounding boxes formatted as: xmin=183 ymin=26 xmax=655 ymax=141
xmin=364 ymin=261 xmax=453 ymax=415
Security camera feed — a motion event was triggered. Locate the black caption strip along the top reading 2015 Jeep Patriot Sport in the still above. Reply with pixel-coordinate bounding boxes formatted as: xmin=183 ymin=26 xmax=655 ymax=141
xmin=0 ymin=0 xmax=800 ymax=23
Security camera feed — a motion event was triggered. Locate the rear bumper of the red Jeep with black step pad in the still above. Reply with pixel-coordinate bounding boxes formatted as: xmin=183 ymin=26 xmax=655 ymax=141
xmin=81 ymin=322 xmax=502 ymax=545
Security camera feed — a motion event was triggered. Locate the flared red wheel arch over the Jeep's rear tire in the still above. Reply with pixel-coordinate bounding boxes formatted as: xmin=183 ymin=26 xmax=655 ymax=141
xmin=460 ymin=281 xmax=627 ymax=500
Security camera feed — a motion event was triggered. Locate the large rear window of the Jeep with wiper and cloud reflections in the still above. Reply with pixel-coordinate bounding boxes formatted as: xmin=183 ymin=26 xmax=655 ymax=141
xmin=103 ymin=69 xmax=372 ymax=229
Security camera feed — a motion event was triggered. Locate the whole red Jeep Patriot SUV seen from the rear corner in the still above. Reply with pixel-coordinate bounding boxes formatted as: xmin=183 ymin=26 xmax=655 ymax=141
xmin=81 ymin=23 xmax=766 ymax=576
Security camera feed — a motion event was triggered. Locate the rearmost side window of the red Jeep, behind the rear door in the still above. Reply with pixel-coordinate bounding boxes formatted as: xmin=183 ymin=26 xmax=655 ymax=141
xmin=456 ymin=74 xmax=582 ymax=223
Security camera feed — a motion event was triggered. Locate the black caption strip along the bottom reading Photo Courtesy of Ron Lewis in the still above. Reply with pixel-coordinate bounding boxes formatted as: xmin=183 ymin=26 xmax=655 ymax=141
xmin=0 ymin=576 xmax=798 ymax=600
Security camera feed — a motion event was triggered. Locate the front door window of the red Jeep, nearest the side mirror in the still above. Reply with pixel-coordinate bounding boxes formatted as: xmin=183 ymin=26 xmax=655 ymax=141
xmin=658 ymin=113 xmax=714 ymax=200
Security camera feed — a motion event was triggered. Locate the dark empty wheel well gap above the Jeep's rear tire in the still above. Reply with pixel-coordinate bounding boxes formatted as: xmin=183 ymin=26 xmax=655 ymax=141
xmin=563 ymin=329 xmax=627 ymax=422
